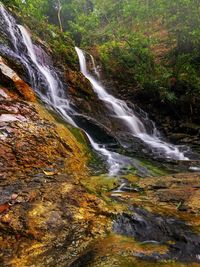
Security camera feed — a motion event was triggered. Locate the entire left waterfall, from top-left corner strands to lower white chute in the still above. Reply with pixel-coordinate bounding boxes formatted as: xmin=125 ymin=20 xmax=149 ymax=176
xmin=0 ymin=6 xmax=122 ymax=175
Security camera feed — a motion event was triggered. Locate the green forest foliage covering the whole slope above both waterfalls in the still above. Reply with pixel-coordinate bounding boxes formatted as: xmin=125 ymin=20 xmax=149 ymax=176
xmin=3 ymin=0 xmax=200 ymax=102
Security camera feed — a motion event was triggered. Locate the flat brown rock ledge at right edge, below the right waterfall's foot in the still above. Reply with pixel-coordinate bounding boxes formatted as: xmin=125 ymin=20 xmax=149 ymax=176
xmin=138 ymin=173 xmax=200 ymax=213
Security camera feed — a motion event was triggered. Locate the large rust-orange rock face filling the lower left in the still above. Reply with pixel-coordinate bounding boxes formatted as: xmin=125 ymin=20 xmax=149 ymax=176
xmin=0 ymin=74 xmax=111 ymax=267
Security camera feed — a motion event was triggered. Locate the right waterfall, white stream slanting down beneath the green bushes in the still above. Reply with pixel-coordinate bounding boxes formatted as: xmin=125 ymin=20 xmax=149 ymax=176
xmin=75 ymin=47 xmax=188 ymax=160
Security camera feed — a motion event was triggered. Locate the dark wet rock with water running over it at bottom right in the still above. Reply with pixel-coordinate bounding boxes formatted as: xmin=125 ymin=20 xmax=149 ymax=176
xmin=113 ymin=208 xmax=200 ymax=263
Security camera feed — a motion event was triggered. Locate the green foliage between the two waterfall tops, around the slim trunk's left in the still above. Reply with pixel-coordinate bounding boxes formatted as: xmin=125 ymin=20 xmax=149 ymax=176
xmin=2 ymin=0 xmax=78 ymax=69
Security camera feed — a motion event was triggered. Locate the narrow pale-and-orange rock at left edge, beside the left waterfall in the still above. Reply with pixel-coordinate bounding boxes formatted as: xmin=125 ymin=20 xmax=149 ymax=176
xmin=0 ymin=57 xmax=36 ymax=102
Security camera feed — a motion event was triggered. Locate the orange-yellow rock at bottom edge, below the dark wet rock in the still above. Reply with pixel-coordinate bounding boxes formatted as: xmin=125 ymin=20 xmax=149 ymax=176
xmin=89 ymin=234 xmax=170 ymax=267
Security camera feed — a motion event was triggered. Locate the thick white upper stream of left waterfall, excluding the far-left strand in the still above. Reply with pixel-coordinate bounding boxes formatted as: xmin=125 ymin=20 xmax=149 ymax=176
xmin=18 ymin=25 xmax=76 ymax=126
